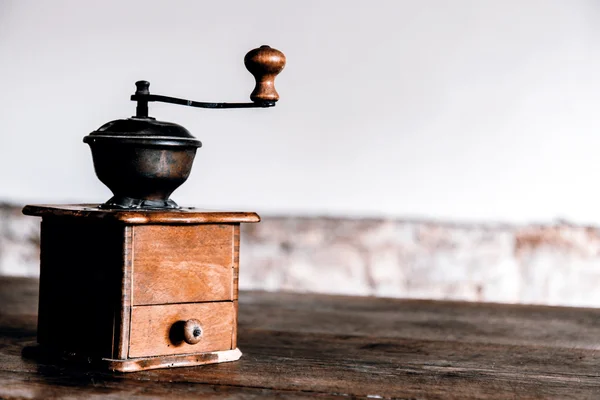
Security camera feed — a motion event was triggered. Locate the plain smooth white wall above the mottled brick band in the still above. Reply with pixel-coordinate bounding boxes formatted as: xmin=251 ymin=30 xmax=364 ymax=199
xmin=0 ymin=0 xmax=600 ymax=223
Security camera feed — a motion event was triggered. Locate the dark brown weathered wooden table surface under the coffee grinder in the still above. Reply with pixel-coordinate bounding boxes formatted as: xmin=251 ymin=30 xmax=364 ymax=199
xmin=0 ymin=278 xmax=600 ymax=399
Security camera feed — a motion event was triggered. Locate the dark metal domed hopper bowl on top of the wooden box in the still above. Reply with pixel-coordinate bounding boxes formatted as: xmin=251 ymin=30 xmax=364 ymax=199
xmin=83 ymin=117 xmax=202 ymax=209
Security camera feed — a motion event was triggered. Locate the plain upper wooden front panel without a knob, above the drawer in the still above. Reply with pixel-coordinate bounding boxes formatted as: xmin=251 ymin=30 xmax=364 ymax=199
xmin=132 ymin=224 xmax=235 ymax=305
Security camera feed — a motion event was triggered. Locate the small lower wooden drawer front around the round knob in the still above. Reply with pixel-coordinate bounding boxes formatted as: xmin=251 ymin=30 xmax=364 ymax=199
xmin=129 ymin=301 xmax=235 ymax=358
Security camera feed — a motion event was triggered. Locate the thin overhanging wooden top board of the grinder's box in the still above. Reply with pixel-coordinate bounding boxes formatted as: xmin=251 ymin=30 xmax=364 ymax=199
xmin=23 ymin=204 xmax=260 ymax=225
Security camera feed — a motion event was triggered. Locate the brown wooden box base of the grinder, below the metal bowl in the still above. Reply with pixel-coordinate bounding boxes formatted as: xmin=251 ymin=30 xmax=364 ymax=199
xmin=23 ymin=205 xmax=259 ymax=372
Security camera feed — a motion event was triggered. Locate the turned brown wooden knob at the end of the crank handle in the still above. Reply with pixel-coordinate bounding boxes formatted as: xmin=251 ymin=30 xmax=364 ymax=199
xmin=244 ymin=46 xmax=285 ymax=102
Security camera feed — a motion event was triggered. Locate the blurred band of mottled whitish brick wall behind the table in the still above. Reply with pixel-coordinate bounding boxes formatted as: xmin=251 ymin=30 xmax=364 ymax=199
xmin=0 ymin=206 xmax=600 ymax=307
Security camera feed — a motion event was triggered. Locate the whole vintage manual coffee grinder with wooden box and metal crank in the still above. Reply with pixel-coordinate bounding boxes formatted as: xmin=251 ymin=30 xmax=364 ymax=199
xmin=23 ymin=46 xmax=285 ymax=372
